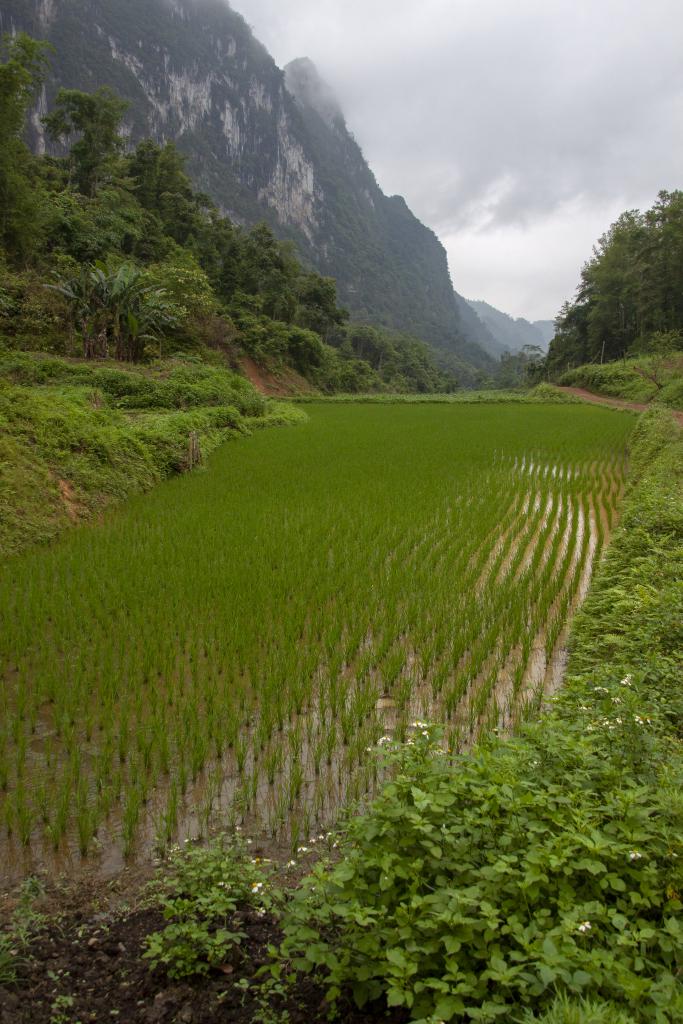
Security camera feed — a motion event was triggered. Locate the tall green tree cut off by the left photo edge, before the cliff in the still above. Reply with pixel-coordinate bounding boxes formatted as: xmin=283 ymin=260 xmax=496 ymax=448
xmin=0 ymin=33 xmax=49 ymax=262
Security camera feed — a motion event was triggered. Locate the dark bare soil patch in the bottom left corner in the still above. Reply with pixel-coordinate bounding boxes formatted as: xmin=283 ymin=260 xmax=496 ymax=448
xmin=0 ymin=890 xmax=407 ymax=1024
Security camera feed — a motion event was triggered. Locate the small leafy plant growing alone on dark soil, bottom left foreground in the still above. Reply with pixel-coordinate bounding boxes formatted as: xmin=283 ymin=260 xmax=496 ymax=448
xmin=143 ymin=837 xmax=281 ymax=978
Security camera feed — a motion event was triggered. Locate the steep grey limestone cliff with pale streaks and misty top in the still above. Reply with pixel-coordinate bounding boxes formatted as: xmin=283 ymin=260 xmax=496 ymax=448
xmin=0 ymin=0 xmax=488 ymax=367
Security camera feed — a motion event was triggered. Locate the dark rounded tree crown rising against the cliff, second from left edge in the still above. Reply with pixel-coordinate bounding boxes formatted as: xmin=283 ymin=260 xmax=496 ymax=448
xmin=43 ymin=86 xmax=129 ymax=197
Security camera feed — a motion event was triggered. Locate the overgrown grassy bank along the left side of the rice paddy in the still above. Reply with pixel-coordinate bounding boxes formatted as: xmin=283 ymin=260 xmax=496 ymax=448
xmin=0 ymin=351 xmax=303 ymax=555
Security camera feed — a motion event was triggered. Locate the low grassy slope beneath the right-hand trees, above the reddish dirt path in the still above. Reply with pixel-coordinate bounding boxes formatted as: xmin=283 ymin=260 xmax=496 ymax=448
xmin=558 ymin=352 xmax=683 ymax=409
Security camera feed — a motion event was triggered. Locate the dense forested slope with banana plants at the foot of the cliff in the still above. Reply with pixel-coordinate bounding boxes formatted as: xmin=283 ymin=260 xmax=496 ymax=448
xmin=0 ymin=34 xmax=458 ymax=392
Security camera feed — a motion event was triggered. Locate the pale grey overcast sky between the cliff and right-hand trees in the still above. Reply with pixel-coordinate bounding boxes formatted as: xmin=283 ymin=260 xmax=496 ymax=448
xmin=231 ymin=0 xmax=683 ymax=319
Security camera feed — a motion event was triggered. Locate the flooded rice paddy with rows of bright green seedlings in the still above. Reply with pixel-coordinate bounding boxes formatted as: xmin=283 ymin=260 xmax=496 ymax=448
xmin=0 ymin=404 xmax=634 ymax=881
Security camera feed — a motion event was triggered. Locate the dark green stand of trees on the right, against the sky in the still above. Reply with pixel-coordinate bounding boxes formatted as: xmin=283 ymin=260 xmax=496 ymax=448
xmin=546 ymin=190 xmax=683 ymax=377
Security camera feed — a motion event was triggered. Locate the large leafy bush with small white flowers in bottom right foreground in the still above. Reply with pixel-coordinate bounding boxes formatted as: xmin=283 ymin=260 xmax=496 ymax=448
xmin=283 ymin=722 xmax=683 ymax=1021
